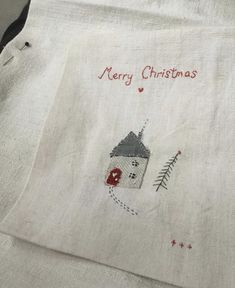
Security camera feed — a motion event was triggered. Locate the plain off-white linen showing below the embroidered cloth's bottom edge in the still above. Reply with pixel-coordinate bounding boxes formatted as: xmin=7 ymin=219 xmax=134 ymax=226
xmin=0 ymin=236 xmax=175 ymax=288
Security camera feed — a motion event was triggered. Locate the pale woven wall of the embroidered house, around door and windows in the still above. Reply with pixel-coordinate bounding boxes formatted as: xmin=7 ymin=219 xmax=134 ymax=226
xmin=105 ymin=156 xmax=148 ymax=188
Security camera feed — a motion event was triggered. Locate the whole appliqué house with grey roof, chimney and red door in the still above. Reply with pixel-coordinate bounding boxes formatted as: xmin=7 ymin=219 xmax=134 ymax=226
xmin=105 ymin=129 xmax=150 ymax=189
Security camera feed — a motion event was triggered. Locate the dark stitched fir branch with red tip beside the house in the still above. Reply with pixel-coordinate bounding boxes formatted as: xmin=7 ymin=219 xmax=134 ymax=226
xmin=153 ymin=151 xmax=181 ymax=192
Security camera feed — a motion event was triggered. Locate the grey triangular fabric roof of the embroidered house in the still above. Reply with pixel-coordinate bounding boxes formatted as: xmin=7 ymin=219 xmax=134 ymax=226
xmin=110 ymin=131 xmax=150 ymax=158
